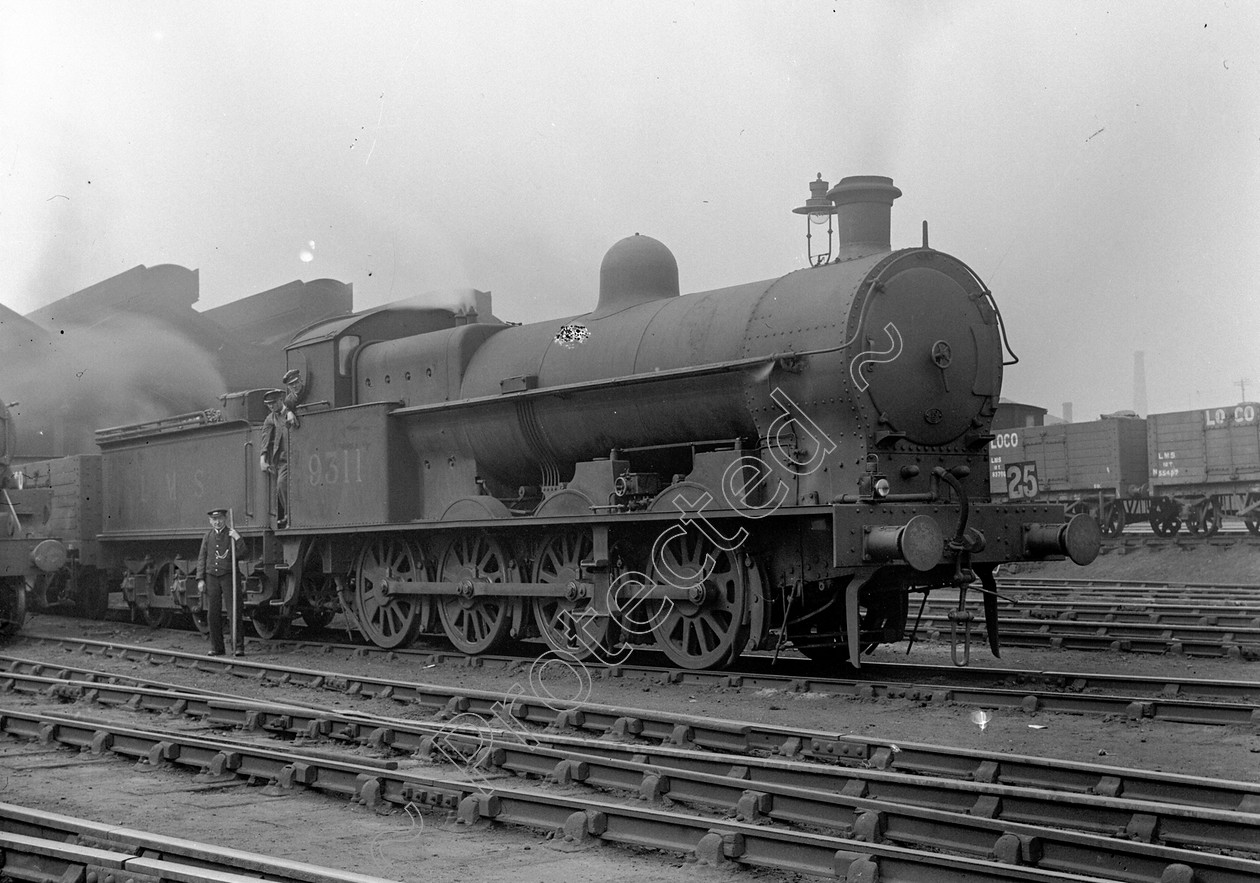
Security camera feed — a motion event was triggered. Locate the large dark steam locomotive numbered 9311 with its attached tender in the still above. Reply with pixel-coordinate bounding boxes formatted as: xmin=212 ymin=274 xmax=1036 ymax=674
xmin=97 ymin=176 xmax=1099 ymax=668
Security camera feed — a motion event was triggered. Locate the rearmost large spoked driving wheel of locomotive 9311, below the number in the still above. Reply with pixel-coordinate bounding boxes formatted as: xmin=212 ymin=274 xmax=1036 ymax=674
xmin=354 ymin=537 xmax=428 ymax=650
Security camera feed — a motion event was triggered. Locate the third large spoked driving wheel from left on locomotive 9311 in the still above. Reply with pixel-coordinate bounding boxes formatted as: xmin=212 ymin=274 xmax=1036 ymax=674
xmin=533 ymin=530 xmax=611 ymax=661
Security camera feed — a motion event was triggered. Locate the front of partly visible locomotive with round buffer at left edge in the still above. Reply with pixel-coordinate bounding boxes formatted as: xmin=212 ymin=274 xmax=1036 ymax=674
xmin=0 ymin=401 xmax=66 ymax=637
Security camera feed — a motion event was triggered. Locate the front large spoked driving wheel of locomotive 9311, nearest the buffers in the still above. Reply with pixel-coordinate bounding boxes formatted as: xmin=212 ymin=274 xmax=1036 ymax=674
xmin=650 ymin=528 xmax=748 ymax=669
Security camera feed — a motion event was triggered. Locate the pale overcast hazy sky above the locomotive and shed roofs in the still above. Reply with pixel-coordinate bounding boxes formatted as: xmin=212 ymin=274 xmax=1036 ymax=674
xmin=0 ymin=0 xmax=1260 ymax=419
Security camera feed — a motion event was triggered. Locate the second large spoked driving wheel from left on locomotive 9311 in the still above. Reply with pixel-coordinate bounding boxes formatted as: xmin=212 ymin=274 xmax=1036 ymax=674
xmin=437 ymin=534 xmax=514 ymax=654
